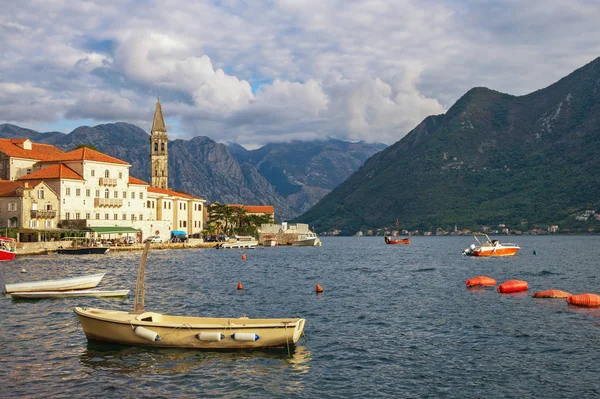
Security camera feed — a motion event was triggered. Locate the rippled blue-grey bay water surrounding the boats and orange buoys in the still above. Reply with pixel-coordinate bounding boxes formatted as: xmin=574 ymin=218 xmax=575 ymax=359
xmin=0 ymin=236 xmax=600 ymax=398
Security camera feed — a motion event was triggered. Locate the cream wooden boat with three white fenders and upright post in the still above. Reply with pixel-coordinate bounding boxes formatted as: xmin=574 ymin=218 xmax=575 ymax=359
xmin=73 ymin=242 xmax=306 ymax=350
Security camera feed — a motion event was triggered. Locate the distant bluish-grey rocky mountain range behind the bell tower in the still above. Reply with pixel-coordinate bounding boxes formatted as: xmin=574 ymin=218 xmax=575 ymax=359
xmin=0 ymin=123 xmax=387 ymax=220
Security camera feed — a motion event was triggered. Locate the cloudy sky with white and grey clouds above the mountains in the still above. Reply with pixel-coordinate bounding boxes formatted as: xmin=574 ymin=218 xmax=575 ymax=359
xmin=0 ymin=0 xmax=600 ymax=148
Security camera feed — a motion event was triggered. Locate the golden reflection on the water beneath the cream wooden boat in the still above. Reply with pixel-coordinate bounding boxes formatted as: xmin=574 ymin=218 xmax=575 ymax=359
xmin=79 ymin=342 xmax=312 ymax=376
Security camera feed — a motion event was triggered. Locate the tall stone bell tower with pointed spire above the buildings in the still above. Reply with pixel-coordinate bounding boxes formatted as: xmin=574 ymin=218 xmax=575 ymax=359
xmin=150 ymin=99 xmax=169 ymax=188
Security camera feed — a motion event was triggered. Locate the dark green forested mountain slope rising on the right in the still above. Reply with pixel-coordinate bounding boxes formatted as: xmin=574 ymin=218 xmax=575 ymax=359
xmin=296 ymin=54 xmax=600 ymax=234
